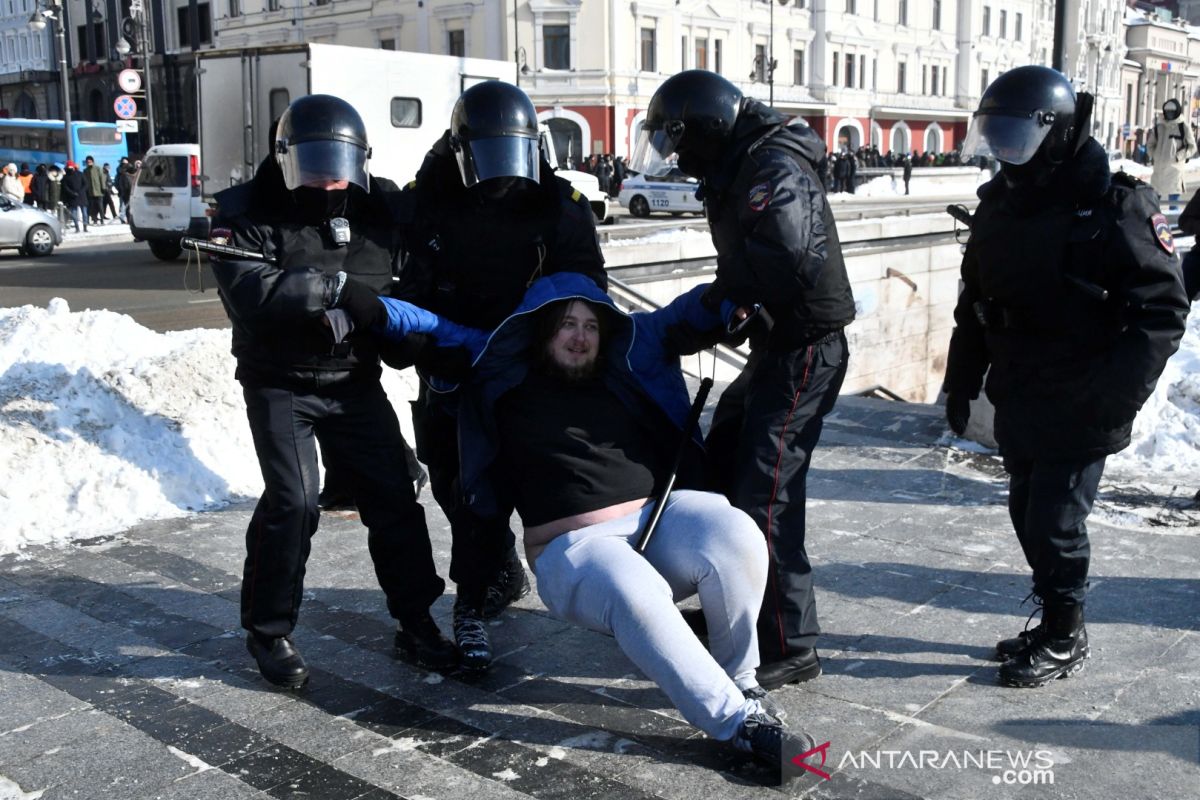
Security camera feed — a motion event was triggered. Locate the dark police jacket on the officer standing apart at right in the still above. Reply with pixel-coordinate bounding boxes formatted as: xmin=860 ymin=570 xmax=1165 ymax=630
xmin=946 ymin=139 xmax=1188 ymax=461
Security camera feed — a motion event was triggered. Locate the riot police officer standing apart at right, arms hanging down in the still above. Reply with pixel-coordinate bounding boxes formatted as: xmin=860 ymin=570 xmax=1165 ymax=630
xmin=946 ymin=66 xmax=1188 ymax=687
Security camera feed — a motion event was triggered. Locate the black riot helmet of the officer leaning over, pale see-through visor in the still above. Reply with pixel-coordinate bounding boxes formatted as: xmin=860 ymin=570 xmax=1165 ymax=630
xmin=629 ymin=70 xmax=742 ymax=178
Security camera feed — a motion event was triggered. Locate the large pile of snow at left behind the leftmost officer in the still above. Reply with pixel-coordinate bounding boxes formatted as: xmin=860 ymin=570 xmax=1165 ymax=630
xmin=0 ymin=299 xmax=415 ymax=554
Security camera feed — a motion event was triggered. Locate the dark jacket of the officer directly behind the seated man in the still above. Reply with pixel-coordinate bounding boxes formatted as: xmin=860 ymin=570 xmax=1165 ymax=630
xmin=392 ymin=134 xmax=607 ymax=331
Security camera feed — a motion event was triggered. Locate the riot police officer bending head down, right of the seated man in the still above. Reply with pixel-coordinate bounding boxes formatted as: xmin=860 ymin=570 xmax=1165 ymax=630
xmin=631 ymin=70 xmax=854 ymax=688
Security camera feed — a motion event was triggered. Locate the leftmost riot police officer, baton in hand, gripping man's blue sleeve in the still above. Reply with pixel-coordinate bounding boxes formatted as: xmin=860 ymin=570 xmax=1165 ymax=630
xmin=212 ymin=95 xmax=457 ymax=687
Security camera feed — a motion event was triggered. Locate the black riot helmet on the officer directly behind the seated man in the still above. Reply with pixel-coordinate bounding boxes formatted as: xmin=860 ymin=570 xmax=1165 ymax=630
xmin=450 ymin=80 xmax=541 ymax=187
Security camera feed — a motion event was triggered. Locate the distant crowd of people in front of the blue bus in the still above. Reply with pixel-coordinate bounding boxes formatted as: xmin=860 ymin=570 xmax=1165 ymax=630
xmin=0 ymin=156 xmax=142 ymax=233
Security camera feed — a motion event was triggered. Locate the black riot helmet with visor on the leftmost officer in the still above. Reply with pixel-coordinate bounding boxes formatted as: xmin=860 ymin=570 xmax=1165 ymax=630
xmin=274 ymin=95 xmax=371 ymax=192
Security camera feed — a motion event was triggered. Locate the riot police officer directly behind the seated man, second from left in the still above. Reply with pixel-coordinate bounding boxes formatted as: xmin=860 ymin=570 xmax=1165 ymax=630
xmin=392 ymin=80 xmax=607 ymax=669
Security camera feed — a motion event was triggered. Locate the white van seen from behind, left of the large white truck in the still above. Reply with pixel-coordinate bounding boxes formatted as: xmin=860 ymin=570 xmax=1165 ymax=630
xmin=128 ymin=144 xmax=209 ymax=261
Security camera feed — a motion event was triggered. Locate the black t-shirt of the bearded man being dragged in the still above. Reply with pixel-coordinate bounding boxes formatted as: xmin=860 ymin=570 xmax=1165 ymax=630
xmin=496 ymin=369 xmax=664 ymax=527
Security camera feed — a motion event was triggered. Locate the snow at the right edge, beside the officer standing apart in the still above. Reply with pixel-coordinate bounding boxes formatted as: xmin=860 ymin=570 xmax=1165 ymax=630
xmin=1109 ymin=302 xmax=1200 ymax=477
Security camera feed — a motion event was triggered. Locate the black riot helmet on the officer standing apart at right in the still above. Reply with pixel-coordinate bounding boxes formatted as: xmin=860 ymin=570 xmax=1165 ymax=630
xmin=962 ymin=66 xmax=1092 ymax=168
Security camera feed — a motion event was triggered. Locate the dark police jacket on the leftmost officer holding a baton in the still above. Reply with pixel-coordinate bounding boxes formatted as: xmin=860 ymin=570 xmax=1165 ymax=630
xmin=212 ymin=160 xmax=398 ymax=391
